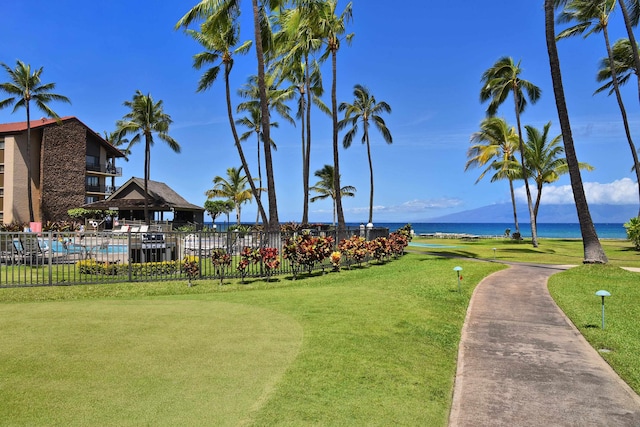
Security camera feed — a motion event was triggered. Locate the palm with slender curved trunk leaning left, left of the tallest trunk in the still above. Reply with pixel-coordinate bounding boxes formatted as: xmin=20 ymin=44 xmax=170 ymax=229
xmin=186 ymin=19 xmax=268 ymax=224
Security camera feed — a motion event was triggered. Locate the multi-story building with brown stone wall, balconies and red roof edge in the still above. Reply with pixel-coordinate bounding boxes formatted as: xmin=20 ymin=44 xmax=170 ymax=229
xmin=0 ymin=117 xmax=124 ymax=224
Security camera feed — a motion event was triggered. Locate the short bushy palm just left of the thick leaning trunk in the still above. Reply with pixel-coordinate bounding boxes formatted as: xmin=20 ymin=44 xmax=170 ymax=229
xmin=524 ymin=122 xmax=593 ymax=224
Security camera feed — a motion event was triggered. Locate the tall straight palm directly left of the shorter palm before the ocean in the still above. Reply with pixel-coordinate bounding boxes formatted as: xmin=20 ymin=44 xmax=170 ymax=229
xmin=313 ymin=0 xmax=353 ymax=231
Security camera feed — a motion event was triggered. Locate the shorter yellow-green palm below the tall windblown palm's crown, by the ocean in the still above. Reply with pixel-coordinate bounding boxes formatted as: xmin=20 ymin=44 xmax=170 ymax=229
xmin=464 ymin=117 xmax=522 ymax=234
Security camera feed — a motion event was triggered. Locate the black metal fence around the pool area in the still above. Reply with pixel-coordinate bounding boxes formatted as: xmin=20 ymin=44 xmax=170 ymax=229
xmin=0 ymin=228 xmax=389 ymax=287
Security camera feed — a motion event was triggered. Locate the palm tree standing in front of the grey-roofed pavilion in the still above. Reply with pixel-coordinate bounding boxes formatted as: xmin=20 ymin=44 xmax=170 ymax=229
xmin=116 ymin=90 xmax=180 ymax=225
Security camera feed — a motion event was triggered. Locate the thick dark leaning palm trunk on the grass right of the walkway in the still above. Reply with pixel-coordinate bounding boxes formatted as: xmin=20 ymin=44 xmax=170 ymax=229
xmin=544 ymin=0 xmax=607 ymax=263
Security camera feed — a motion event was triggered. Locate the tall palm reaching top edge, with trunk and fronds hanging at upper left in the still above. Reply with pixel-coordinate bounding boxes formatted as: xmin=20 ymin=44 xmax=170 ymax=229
xmin=176 ymin=0 xmax=283 ymax=231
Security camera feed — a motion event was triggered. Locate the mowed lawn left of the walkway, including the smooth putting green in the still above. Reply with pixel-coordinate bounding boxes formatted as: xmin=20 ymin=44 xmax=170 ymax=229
xmin=0 ymin=254 xmax=503 ymax=426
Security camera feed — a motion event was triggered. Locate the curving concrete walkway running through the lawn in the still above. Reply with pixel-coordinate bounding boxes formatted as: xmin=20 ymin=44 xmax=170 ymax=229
xmin=449 ymin=264 xmax=640 ymax=427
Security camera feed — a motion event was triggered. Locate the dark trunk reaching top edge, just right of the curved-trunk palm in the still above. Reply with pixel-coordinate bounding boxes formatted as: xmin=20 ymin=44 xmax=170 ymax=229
xmin=251 ymin=0 xmax=280 ymax=231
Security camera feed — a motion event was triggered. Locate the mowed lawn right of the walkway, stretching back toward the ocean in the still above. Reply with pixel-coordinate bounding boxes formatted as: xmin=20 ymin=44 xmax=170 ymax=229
xmin=410 ymin=239 xmax=640 ymax=394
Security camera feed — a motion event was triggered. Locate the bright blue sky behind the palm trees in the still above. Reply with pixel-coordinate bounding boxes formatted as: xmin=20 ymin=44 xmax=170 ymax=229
xmin=0 ymin=0 xmax=640 ymax=223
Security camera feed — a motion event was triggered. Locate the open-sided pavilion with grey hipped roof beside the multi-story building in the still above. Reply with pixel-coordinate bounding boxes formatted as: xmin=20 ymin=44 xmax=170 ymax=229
xmin=83 ymin=177 xmax=204 ymax=226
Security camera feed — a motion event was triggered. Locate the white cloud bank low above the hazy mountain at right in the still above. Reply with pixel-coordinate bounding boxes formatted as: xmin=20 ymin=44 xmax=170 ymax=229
xmin=515 ymin=178 xmax=638 ymax=205
